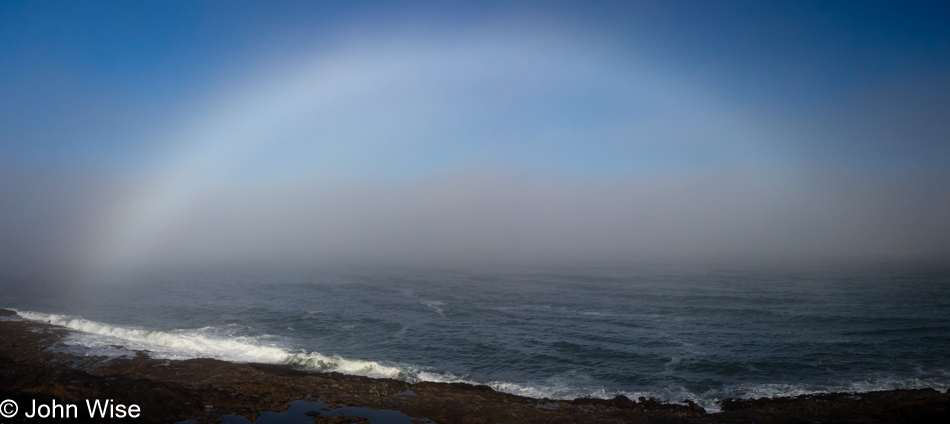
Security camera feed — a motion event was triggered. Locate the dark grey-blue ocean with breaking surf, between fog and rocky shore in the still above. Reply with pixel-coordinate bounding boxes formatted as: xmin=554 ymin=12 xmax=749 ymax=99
xmin=0 ymin=264 xmax=950 ymax=411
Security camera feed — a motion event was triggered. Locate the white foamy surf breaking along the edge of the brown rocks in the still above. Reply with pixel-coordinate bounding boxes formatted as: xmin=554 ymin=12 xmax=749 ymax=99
xmin=9 ymin=311 xmax=950 ymax=412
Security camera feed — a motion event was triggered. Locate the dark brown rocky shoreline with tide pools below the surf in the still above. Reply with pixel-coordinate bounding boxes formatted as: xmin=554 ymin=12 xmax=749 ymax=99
xmin=0 ymin=309 xmax=950 ymax=424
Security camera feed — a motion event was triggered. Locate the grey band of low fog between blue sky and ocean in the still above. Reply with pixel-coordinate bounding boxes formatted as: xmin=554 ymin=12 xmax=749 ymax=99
xmin=0 ymin=164 xmax=950 ymax=276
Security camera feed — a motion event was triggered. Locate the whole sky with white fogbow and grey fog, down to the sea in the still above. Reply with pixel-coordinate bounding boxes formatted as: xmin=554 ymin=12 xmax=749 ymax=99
xmin=0 ymin=1 xmax=950 ymax=270
